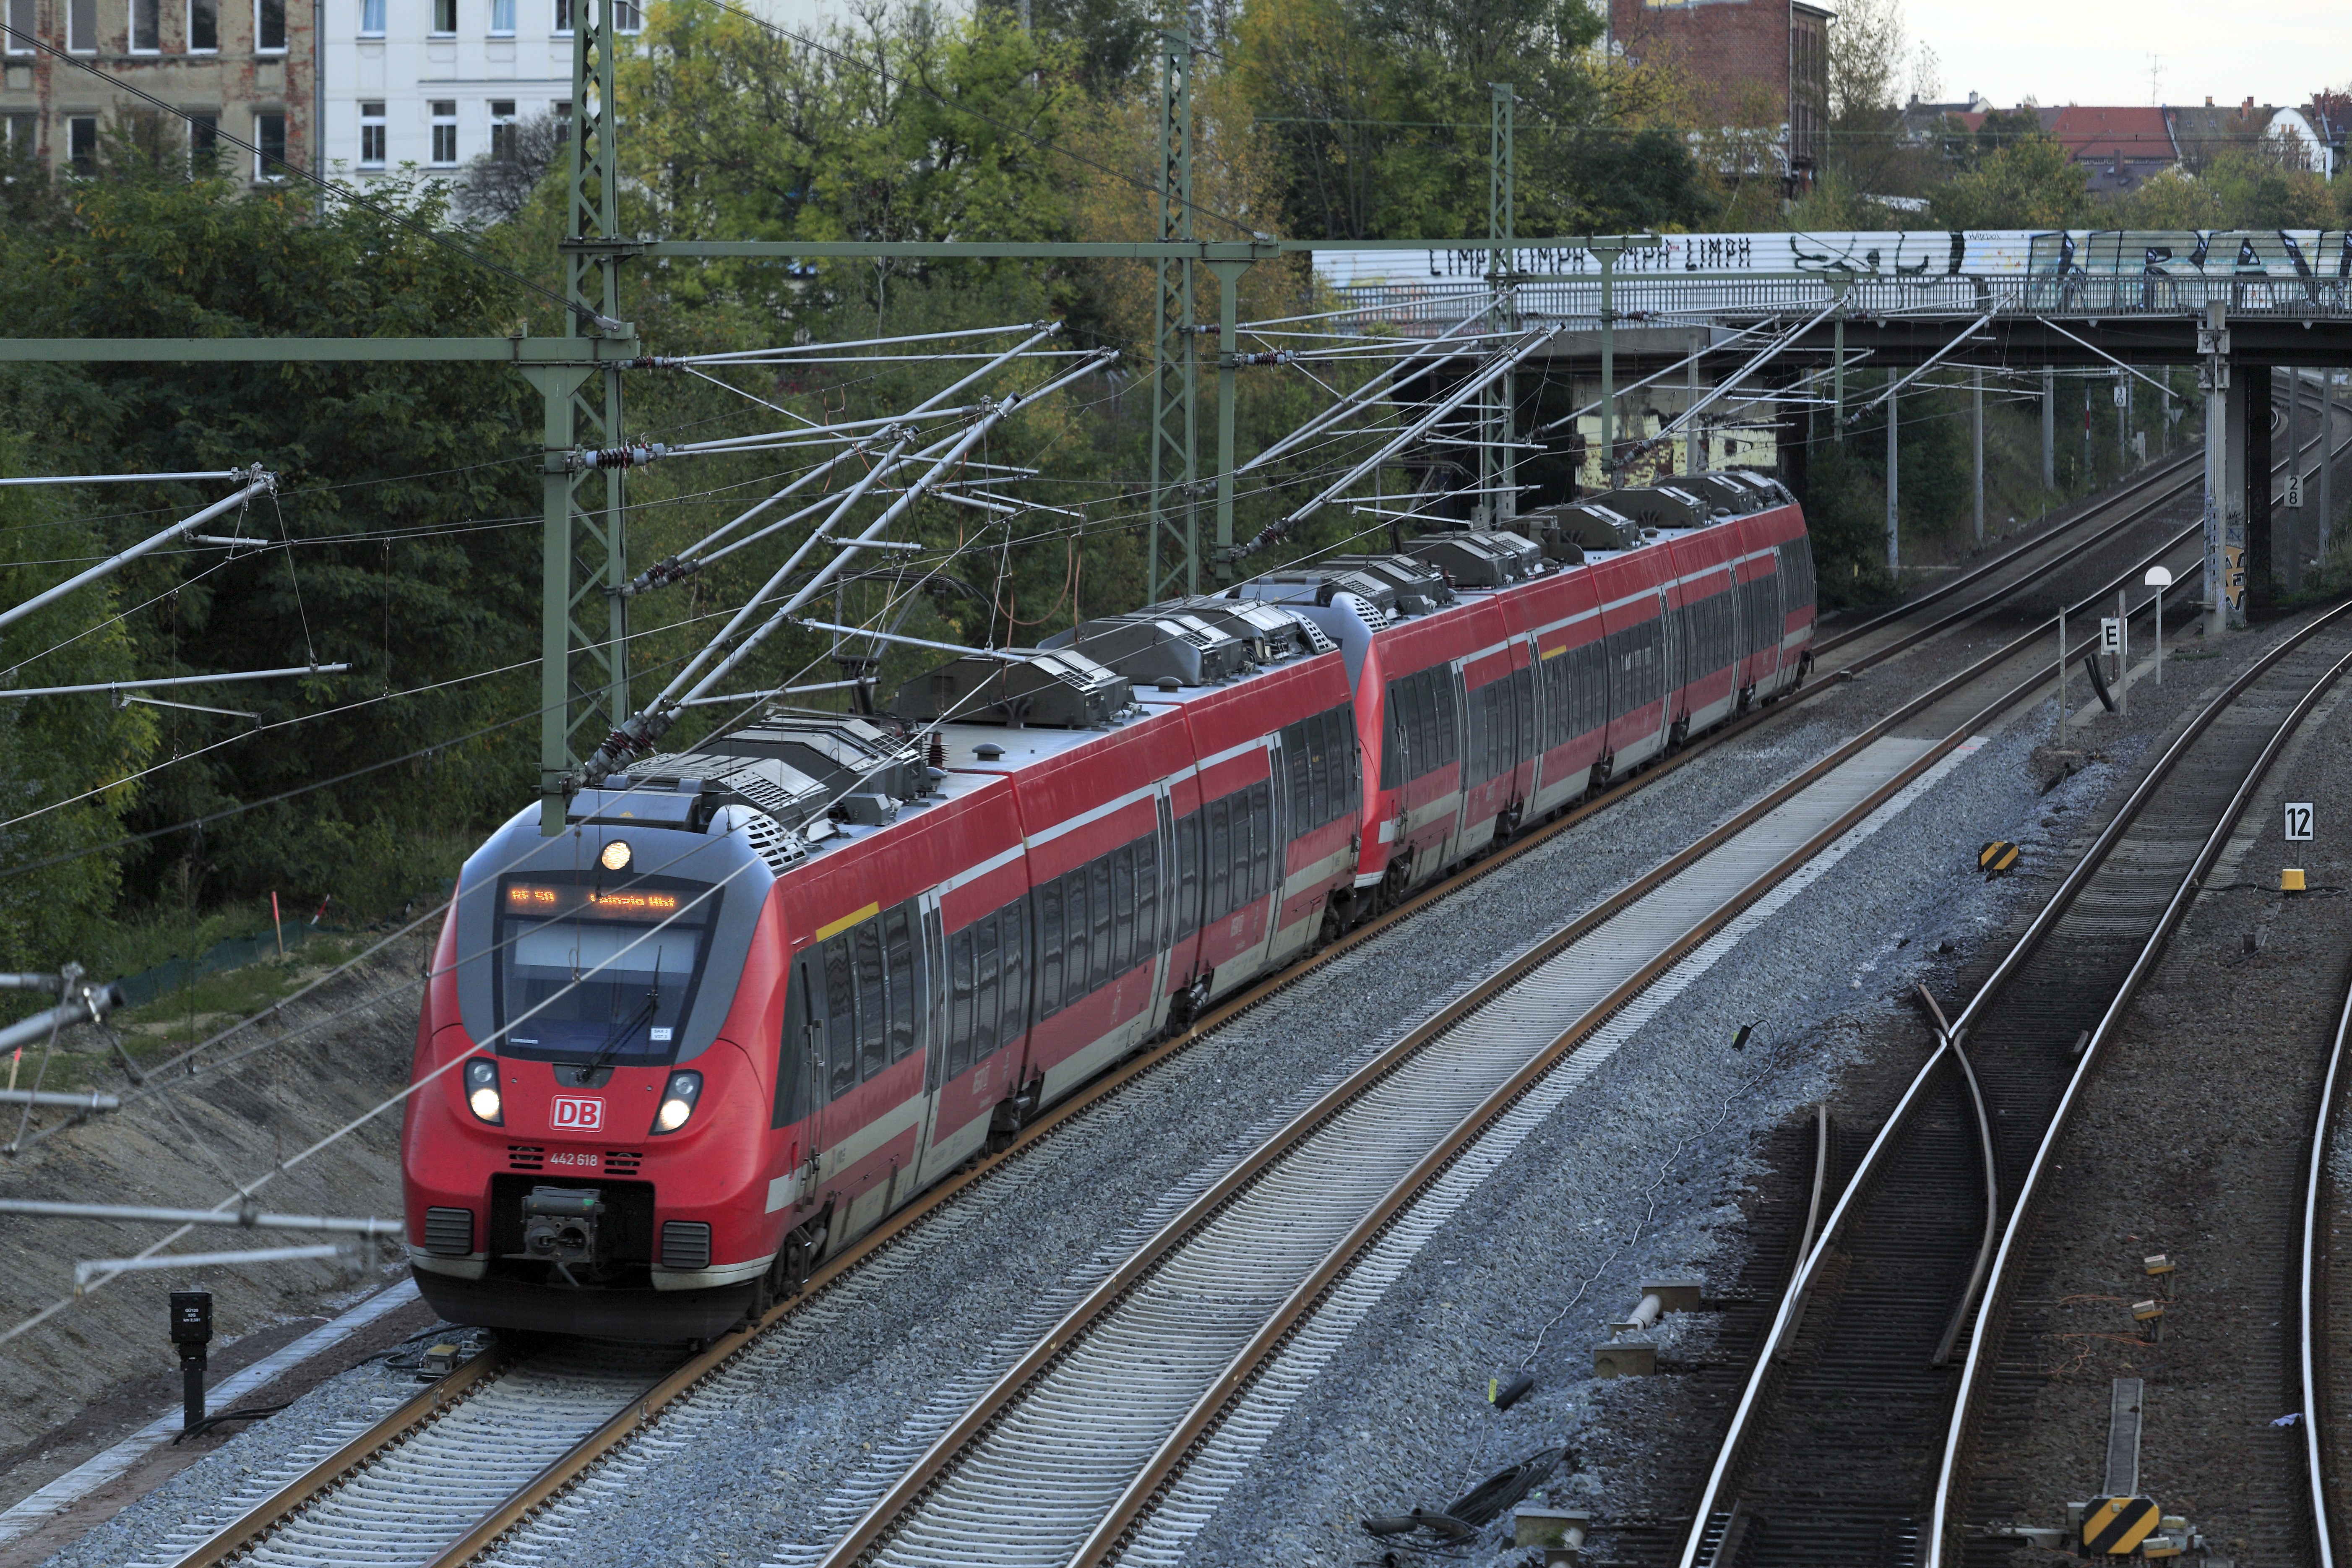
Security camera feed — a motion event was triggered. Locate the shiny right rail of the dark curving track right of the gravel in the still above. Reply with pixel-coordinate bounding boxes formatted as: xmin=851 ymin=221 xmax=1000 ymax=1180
xmin=1926 ymin=620 xmax=2352 ymax=1568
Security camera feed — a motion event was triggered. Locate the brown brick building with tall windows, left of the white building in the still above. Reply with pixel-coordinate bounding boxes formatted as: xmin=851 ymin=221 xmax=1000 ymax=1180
xmin=0 ymin=0 xmax=315 ymax=181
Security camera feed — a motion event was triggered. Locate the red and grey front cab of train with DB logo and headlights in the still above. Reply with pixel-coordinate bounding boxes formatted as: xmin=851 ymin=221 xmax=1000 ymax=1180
xmin=402 ymin=809 xmax=783 ymax=1340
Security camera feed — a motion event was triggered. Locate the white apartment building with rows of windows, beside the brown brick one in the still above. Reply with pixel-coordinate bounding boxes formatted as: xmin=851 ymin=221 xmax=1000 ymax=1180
xmin=322 ymin=0 xmax=642 ymax=181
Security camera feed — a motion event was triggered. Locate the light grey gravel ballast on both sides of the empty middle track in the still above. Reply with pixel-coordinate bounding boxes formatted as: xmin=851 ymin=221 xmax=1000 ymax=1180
xmin=36 ymin=616 xmax=2192 ymax=1563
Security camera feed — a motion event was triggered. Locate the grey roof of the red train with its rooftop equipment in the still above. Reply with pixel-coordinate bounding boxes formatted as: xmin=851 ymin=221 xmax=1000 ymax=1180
xmin=592 ymin=470 xmax=1792 ymax=875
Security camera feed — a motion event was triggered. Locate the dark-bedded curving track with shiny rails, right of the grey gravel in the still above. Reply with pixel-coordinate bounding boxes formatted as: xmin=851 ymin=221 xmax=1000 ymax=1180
xmin=1679 ymin=607 xmax=2352 ymax=1568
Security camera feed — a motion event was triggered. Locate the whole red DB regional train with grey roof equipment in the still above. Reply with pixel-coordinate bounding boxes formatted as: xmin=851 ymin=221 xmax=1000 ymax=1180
xmin=402 ymin=472 xmax=1813 ymax=1340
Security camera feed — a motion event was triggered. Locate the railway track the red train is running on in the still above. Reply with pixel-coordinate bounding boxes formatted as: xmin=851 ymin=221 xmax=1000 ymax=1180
xmin=124 ymin=432 xmax=2239 ymax=1568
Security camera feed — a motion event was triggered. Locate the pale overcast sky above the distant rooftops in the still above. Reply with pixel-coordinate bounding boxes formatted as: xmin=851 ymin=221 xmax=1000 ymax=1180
xmin=1919 ymin=0 xmax=2352 ymax=106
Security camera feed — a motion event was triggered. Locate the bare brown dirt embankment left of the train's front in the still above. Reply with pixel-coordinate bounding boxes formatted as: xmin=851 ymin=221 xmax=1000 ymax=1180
xmin=0 ymin=931 xmax=430 ymax=1476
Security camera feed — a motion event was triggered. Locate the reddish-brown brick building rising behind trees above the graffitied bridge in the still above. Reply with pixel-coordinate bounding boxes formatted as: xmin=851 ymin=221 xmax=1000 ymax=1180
xmin=1609 ymin=0 xmax=1834 ymax=188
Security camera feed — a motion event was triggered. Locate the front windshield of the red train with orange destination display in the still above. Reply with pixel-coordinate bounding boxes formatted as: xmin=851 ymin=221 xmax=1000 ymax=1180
xmin=496 ymin=877 xmax=720 ymax=1067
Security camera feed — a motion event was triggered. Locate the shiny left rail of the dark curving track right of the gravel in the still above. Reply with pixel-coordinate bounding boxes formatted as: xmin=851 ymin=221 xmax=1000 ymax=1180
xmin=1677 ymin=588 xmax=2352 ymax=1568
